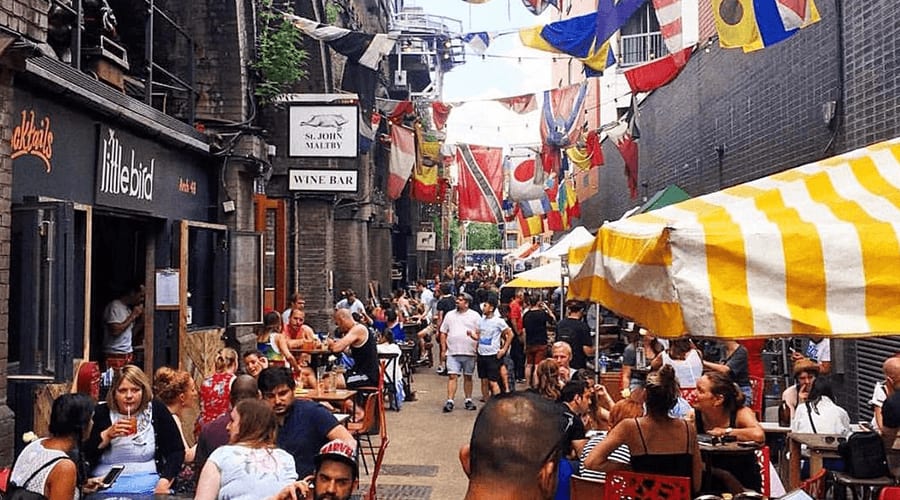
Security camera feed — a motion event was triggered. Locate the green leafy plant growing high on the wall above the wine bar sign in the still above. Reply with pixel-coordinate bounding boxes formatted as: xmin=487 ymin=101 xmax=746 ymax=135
xmin=253 ymin=0 xmax=309 ymax=102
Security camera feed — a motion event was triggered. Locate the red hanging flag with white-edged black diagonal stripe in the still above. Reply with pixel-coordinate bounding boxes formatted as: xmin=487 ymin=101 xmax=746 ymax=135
xmin=456 ymin=144 xmax=503 ymax=223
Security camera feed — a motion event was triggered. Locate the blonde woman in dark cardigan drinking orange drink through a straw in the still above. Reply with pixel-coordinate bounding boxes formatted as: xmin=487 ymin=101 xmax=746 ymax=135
xmin=84 ymin=365 xmax=184 ymax=495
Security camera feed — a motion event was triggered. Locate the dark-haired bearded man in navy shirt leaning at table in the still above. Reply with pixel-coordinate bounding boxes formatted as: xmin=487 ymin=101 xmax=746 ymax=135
xmin=258 ymin=366 xmax=356 ymax=477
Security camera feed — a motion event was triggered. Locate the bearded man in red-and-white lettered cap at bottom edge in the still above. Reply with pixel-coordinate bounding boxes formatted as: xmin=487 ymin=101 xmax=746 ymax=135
xmin=275 ymin=440 xmax=359 ymax=500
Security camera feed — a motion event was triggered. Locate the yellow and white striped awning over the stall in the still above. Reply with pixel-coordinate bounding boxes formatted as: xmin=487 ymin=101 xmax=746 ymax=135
xmin=569 ymin=138 xmax=900 ymax=338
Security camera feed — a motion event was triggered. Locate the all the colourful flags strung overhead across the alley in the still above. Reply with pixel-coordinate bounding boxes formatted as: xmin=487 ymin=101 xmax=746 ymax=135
xmin=285 ymin=0 xmax=820 ymax=236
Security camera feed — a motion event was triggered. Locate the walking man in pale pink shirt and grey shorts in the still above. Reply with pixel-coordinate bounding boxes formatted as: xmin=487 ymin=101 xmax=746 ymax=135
xmin=440 ymin=292 xmax=481 ymax=413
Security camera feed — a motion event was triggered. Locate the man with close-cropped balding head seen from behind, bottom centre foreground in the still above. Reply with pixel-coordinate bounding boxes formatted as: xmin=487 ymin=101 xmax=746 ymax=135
xmin=459 ymin=392 xmax=566 ymax=500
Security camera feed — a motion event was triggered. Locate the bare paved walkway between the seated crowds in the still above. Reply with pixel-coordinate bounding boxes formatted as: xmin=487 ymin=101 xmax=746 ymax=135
xmin=360 ymin=367 xmax=482 ymax=500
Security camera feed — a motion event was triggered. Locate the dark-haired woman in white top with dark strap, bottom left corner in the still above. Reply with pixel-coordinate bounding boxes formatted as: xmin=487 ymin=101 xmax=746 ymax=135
xmin=10 ymin=393 xmax=101 ymax=500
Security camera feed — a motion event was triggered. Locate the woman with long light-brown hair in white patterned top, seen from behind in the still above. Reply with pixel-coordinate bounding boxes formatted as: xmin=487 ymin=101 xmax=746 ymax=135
xmin=195 ymin=399 xmax=297 ymax=500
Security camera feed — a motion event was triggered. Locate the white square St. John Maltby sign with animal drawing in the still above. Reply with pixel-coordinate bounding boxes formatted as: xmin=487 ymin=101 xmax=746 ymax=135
xmin=288 ymin=105 xmax=359 ymax=158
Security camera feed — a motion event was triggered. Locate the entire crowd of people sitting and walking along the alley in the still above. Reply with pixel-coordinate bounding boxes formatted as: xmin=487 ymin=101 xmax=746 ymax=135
xmin=12 ymin=264 xmax=900 ymax=499
